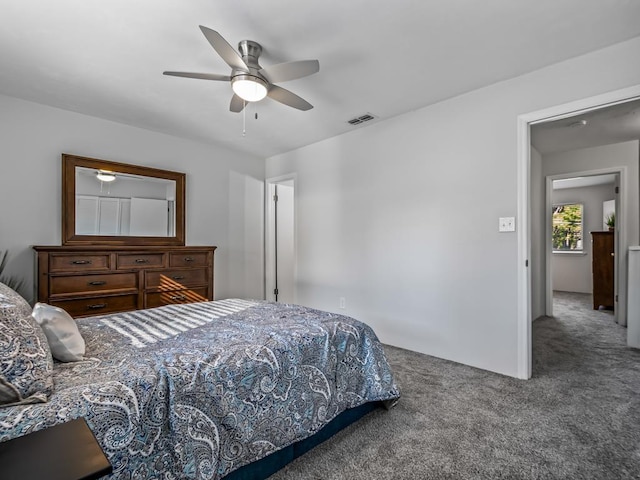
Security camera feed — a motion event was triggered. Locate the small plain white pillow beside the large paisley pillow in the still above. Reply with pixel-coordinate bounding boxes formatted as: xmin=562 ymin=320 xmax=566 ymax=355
xmin=31 ymin=303 xmax=85 ymax=362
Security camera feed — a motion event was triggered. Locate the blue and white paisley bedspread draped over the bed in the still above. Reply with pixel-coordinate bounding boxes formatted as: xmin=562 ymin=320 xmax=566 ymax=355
xmin=0 ymin=299 xmax=399 ymax=479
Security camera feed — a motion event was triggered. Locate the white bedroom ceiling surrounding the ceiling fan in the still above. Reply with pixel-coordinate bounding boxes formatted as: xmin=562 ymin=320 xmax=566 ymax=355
xmin=0 ymin=0 xmax=640 ymax=157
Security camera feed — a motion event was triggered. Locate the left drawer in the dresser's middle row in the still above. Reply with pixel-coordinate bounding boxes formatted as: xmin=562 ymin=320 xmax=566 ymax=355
xmin=49 ymin=272 xmax=138 ymax=295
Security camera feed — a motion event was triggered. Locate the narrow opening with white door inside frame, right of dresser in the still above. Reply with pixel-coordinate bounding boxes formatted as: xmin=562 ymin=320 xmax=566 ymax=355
xmin=265 ymin=176 xmax=296 ymax=303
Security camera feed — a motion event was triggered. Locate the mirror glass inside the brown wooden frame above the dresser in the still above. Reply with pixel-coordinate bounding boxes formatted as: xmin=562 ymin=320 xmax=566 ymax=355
xmin=75 ymin=166 xmax=176 ymax=237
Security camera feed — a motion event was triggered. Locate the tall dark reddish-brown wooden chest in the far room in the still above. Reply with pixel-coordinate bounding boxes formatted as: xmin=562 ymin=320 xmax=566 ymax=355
xmin=591 ymin=232 xmax=615 ymax=310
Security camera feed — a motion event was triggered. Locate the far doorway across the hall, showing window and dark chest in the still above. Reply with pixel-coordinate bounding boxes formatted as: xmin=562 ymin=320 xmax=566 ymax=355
xmin=545 ymin=172 xmax=626 ymax=323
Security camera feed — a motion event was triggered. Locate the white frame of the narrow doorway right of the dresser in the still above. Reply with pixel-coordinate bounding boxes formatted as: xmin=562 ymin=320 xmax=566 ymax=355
xmin=264 ymin=173 xmax=298 ymax=303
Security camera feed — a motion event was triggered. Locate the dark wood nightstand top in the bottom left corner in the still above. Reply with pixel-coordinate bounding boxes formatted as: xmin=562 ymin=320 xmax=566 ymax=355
xmin=0 ymin=418 xmax=113 ymax=480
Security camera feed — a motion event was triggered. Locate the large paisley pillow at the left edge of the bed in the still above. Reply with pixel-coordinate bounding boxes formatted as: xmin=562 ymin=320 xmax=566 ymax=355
xmin=0 ymin=283 xmax=53 ymax=405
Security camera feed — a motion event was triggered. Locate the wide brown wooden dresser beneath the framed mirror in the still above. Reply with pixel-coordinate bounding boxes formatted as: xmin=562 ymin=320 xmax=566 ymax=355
xmin=33 ymin=246 xmax=216 ymax=317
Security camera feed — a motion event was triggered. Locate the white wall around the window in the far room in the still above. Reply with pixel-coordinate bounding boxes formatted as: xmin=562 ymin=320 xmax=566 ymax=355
xmin=551 ymin=184 xmax=615 ymax=293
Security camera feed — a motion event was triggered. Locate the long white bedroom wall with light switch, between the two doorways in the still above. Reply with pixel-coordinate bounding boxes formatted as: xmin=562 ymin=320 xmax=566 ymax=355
xmin=266 ymin=38 xmax=640 ymax=376
